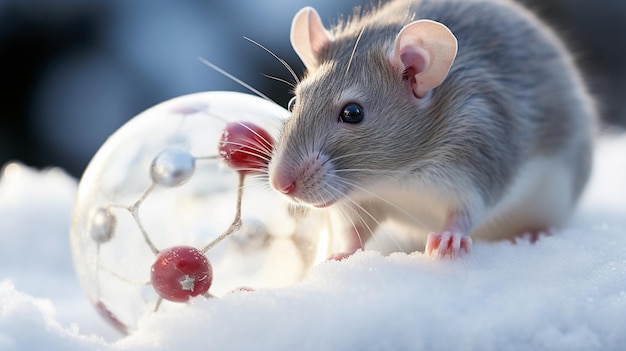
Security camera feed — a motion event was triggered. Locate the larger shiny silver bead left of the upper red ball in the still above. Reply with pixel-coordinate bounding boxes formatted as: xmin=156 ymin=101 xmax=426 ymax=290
xmin=150 ymin=149 xmax=196 ymax=187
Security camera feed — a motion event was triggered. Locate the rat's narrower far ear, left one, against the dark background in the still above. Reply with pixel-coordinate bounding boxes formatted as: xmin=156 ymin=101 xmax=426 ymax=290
xmin=290 ymin=7 xmax=333 ymax=70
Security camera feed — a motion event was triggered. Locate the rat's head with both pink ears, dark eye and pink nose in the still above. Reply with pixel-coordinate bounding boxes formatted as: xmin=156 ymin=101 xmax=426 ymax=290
xmin=269 ymin=8 xmax=457 ymax=207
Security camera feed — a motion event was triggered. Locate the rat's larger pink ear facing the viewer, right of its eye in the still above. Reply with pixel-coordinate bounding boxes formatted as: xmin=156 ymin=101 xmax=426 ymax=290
xmin=389 ymin=20 xmax=457 ymax=98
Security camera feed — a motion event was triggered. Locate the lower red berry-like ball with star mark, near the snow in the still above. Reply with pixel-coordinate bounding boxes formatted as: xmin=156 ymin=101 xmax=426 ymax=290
xmin=150 ymin=246 xmax=213 ymax=302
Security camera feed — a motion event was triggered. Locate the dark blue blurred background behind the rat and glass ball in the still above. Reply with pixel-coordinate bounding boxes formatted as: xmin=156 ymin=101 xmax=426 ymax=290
xmin=0 ymin=0 xmax=626 ymax=177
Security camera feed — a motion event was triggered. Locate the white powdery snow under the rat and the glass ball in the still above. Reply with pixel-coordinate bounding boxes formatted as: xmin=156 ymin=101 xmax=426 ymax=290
xmin=0 ymin=135 xmax=626 ymax=351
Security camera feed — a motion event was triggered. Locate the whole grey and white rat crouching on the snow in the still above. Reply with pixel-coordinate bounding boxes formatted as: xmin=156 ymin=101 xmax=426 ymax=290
xmin=268 ymin=0 xmax=597 ymax=259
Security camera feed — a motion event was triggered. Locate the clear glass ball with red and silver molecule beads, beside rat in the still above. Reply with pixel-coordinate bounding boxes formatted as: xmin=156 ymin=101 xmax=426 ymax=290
xmin=71 ymin=92 xmax=329 ymax=333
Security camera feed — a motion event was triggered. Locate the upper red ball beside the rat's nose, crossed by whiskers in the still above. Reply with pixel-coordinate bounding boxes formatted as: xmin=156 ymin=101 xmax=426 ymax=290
xmin=217 ymin=122 xmax=274 ymax=173
